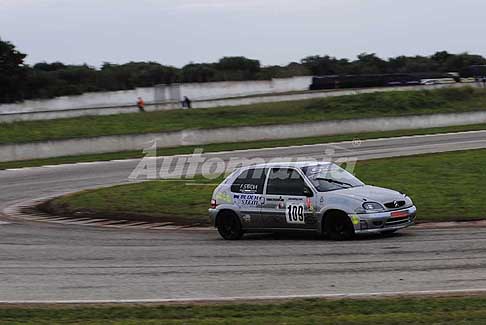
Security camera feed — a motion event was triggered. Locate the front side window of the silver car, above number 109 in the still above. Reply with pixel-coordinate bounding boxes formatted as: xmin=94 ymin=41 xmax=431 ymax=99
xmin=267 ymin=168 xmax=306 ymax=196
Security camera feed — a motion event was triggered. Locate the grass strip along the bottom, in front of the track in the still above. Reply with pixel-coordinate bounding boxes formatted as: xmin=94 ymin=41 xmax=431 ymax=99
xmin=0 ymin=296 xmax=486 ymax=325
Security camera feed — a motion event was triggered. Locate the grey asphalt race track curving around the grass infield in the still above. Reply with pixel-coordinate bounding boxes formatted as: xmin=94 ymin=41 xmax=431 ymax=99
xmin=0 ymin=131 xmax=486 ymax=302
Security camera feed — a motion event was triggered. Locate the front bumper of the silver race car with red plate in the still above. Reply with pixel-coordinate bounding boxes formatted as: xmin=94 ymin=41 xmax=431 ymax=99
xmin=349 ymin=206 xmax=417 ymax=234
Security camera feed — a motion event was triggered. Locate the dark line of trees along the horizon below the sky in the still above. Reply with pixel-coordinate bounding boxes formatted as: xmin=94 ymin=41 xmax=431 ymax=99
xmin=0 ymin=39 xmax=486 ymax=103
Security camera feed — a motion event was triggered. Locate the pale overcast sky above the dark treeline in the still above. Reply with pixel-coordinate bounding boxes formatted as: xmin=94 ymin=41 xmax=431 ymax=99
xmin=0 ymin=0 xmax=486 ymax=67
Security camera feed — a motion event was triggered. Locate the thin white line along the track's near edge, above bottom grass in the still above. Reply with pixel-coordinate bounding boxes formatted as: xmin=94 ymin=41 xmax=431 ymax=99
xmin=0 ymin=288 xmax=486 ymax=305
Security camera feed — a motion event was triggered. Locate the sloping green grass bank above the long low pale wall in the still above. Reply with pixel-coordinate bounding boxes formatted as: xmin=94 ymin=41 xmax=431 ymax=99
xmin=0 ymin=87 xmax=486 ymax=143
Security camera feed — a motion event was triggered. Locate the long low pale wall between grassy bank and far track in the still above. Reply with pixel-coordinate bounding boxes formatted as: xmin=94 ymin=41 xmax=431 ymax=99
xmin=0 ymin=111 xmax=486 ymax=162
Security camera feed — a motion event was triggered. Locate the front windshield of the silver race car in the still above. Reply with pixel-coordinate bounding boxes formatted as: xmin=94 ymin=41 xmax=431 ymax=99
xmin=302 ymin=164 xmax=364 ymax=192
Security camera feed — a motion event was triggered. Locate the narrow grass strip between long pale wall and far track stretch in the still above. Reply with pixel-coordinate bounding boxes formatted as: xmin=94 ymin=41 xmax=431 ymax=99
xmin=0 ymin=124 xmax=486 ymax=170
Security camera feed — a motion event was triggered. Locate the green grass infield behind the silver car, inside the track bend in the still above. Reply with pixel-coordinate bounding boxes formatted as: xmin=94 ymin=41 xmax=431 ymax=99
xmin=47 ymin=150 xmax=486 ymax=224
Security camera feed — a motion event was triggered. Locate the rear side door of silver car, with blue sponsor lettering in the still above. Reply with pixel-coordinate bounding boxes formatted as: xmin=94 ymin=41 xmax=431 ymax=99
xmin=231 ymin=168 xmax=267 ymax=229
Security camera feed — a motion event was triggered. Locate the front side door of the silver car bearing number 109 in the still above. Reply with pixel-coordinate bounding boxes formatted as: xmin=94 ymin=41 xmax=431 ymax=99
xmin=261 ymin=168 xmax=317 ymax=229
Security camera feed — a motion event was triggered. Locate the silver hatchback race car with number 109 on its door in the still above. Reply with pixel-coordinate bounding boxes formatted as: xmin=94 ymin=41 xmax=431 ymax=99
xmin=209 ymin=162 xmax=416 ymax=240
